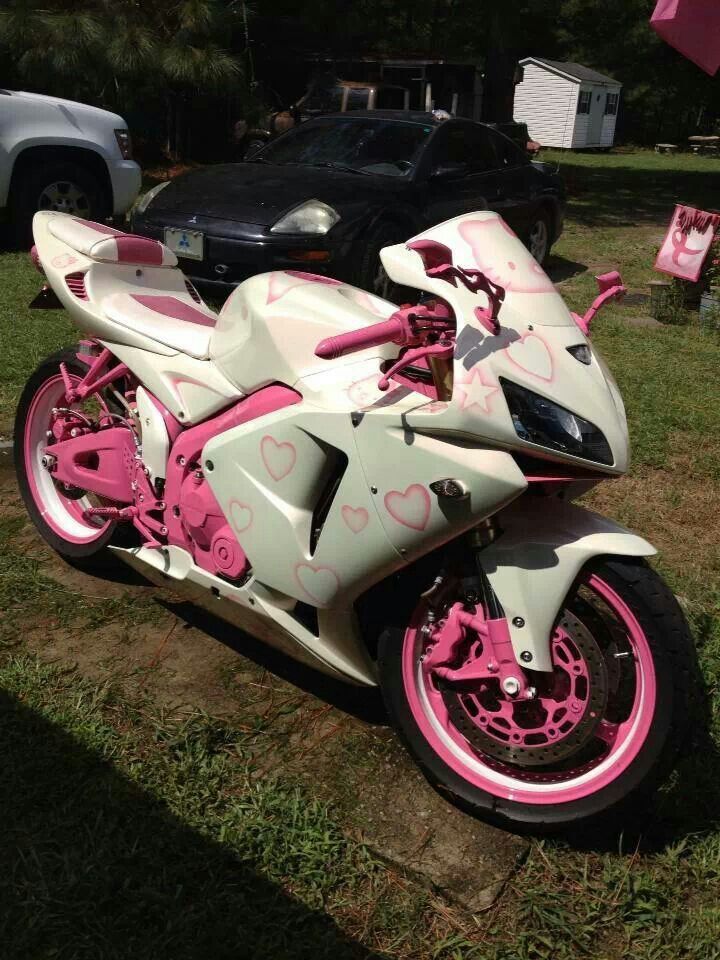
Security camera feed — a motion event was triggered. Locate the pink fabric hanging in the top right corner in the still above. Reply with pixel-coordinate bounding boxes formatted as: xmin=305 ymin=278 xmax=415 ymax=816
xmin=650 ymin=0 xmax=720 ymax=76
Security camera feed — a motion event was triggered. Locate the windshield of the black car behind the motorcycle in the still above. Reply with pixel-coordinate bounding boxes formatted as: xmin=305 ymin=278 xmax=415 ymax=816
xmin=252 ymin=118 xmax=433 ymax=177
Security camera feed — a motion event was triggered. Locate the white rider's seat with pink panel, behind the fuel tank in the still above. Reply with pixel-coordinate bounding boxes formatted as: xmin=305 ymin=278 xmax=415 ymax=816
xmin=102 ymin=288 xmax=217 ymax=360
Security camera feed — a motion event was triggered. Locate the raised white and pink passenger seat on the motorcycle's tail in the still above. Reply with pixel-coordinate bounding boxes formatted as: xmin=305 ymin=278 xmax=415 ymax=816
xmin=48 ymin=216 xmax=177 ymax=267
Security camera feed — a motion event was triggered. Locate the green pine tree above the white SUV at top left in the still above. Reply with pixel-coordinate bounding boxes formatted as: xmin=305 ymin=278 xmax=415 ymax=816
xmin=0 ymin=0 xmax=242 ymax=155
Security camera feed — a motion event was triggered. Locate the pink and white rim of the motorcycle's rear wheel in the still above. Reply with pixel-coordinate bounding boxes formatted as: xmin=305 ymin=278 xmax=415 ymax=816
xmin=23 ymin=373 xmax=108 ymax=545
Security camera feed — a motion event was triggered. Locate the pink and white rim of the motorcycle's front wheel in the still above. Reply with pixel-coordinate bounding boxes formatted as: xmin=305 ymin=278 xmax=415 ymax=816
xmin=402 ymin=574 xmax=657 ymax=804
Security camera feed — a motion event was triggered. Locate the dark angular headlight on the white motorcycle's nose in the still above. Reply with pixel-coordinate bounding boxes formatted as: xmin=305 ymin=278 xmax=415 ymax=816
xmin=500 ymin=377 xmax=614 ymax=465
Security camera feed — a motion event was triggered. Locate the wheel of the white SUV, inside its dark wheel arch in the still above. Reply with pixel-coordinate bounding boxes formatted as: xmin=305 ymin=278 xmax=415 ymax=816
xmin=10 ymin=163 xmax=110 ymax=244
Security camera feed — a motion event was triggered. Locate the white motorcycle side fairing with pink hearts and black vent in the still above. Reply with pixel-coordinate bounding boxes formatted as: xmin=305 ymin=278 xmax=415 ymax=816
xmin=203 ymin=384 xmax=526 ymax=608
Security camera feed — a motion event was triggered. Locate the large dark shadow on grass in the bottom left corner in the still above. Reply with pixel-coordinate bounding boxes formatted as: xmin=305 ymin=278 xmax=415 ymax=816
xmin=0 ymin=692 xmax=388 ymax=960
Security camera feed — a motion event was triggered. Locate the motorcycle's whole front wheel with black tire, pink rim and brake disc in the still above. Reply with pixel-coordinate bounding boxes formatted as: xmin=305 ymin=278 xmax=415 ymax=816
xmin=378 ymin=559 xmax=695 ymax=832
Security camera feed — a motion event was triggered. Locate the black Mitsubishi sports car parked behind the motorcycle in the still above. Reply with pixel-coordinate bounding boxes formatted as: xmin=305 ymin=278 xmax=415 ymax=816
xmin=132 ymin=110 xmax=565 ymax=296
